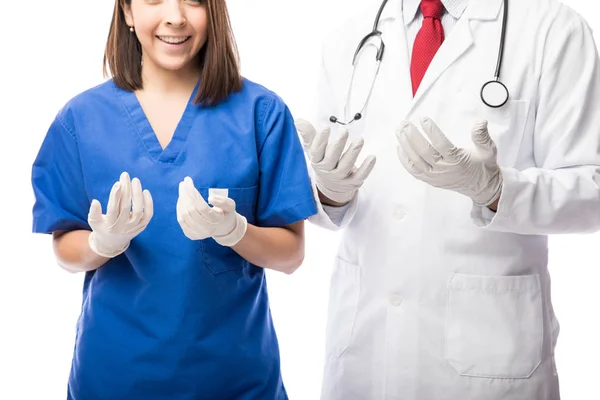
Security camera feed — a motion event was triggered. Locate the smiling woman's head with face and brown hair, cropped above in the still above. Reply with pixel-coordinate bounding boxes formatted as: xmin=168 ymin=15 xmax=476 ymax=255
xmin=104 ymin=0 xmax=242 ymax=105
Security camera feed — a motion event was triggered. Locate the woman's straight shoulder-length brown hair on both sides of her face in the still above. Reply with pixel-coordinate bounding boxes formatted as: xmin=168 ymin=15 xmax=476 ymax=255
xmin=104 ymin=0 xmax=242 ymax=106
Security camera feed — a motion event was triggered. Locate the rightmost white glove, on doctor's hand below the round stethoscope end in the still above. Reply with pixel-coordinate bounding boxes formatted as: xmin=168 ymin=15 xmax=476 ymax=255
xmin=396 ymin=118 xmax=502 ymax=206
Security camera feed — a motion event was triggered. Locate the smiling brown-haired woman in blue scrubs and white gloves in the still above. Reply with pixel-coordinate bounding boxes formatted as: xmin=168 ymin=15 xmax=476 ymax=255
xmin=32 ymin=0 xmax=316 ymax=400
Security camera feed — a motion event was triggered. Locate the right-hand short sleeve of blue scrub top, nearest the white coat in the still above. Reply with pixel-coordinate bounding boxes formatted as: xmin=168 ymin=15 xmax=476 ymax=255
xmin=256 ymin=95 xmax=317 ymax=227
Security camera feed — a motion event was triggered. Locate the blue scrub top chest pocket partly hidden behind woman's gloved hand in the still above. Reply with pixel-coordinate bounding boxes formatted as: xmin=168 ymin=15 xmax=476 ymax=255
xmin=198 ymin=186 xmax=258 ymax=275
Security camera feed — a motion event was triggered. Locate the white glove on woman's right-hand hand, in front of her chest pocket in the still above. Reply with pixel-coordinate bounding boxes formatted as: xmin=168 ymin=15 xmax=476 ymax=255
xmin=177 ymin=177 xmax=248 ymax=246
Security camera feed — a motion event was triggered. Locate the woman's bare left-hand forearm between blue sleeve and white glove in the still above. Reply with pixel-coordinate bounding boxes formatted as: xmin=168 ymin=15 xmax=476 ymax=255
xmin=53 ymin=230 xmax=110 ymax=273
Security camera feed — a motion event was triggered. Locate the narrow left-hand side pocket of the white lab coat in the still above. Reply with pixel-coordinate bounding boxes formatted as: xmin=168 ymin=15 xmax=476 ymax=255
xmin=326 ymin=257 xmax=360 ymax=357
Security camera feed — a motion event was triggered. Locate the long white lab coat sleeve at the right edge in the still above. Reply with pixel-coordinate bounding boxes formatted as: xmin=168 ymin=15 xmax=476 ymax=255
xmin=472 ymin=7 xmax=600 ymax=235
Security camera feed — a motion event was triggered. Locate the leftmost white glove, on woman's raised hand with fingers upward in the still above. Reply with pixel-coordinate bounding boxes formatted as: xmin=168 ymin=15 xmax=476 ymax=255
xmin=88 ymin=172 xmax=154 ymax=258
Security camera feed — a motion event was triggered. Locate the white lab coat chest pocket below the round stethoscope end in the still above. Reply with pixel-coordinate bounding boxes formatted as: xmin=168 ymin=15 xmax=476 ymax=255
xmin=461 ymin=99 xmax=529 ymax=168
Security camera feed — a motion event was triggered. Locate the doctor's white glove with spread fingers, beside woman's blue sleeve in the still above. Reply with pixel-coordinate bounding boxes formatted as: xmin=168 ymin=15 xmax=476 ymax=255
xmin=296 ymin=119 xmax=375 ymax=204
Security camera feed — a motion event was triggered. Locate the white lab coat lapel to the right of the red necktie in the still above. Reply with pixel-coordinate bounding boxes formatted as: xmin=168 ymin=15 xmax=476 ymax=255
xmin=411 ymin=0 xmax=502 ymax=110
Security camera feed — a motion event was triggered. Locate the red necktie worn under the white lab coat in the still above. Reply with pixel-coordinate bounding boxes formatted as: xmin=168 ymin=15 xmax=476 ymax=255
xmin=410 ymin=0 xmax=444 ymax=96
